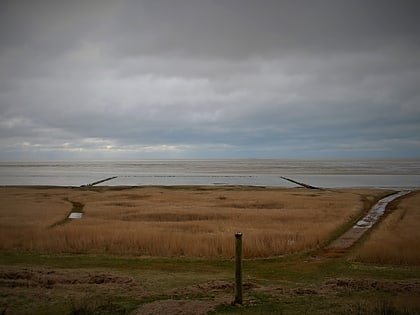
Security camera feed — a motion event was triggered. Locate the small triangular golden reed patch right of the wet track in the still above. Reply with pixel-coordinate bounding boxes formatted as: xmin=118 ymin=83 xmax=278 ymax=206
xmin=354 ymin=191 xmax=420 ymax=265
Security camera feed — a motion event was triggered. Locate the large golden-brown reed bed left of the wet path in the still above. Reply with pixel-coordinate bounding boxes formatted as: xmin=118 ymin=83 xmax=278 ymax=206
xmin=0 ymin=187 xmax=390 ymax=258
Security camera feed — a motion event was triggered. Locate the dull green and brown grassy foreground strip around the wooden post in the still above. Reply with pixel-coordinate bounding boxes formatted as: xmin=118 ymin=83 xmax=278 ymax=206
xmin=0 ymin=251 xmax=420 ymax=314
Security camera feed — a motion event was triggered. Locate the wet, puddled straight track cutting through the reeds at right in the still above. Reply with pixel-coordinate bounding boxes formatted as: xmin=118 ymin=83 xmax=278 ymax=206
xmin=325 ymin=191 xmax=411 ymax=253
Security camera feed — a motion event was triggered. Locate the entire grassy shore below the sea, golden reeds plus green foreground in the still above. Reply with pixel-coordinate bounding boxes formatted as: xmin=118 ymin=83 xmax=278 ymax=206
xmin=0 ymin=186 xmax=420 ymax=315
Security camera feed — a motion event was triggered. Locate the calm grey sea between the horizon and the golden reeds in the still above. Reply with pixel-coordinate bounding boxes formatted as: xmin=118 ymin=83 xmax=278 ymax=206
xmin=0 ymin=159 xmax=420 ymax=189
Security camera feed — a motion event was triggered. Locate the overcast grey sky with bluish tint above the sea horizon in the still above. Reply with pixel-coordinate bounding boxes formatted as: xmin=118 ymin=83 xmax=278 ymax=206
xmin=0 ymin=0 xmax=420 ymax=161
